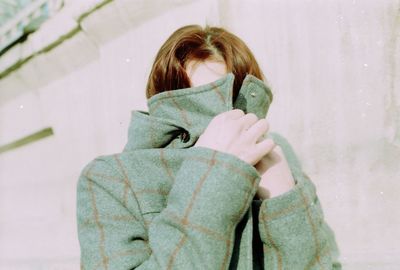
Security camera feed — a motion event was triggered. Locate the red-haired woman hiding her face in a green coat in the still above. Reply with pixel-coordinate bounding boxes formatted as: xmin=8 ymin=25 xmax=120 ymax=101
xmin=77 ymin=25 xmax=341 ymax=270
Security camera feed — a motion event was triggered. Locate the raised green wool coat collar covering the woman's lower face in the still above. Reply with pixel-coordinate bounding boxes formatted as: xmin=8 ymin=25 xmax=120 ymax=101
xmin=123 ymin=72 xmax=273 ymax=151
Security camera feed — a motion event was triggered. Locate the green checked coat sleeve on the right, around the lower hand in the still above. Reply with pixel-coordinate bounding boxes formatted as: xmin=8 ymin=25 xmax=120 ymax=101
xmin=258 ymin=132 xmax=342 ymax=270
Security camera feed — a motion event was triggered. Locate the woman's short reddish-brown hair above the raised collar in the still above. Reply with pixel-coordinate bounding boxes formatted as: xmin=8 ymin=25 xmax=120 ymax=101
xmin=146 ymin=24 xmax=265 ymax=103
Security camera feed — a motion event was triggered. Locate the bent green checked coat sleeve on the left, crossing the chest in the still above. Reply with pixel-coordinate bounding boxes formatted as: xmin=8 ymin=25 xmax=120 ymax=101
xmin=77 ymin=147 xmax=261 ymax=270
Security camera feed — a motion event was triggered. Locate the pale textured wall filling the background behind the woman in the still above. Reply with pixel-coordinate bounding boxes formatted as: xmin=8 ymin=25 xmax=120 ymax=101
xmin=0 ymin=0 xmax=400 ymax=269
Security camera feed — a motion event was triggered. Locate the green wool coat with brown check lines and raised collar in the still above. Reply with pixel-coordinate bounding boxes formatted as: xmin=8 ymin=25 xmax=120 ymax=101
xmin=77 ymin=73 xmax=341 ymax=270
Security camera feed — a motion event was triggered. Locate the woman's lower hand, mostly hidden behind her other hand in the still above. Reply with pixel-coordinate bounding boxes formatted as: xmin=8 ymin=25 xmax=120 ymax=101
xmin=254 ymin=145 xmax=295 ymax=200
